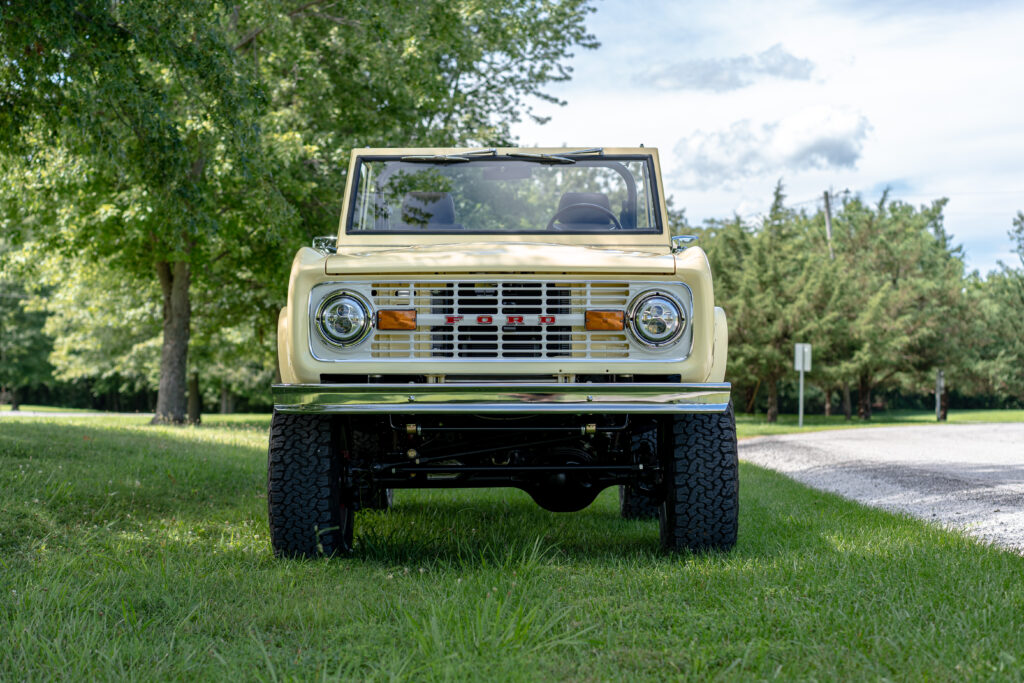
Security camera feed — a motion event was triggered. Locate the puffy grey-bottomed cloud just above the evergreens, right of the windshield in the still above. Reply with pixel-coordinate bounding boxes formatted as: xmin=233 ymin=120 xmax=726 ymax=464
xmin=672 ymin=108 xmax=870 ymax=189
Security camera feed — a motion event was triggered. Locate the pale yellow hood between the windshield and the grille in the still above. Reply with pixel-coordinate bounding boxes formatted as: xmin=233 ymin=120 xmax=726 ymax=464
xmin=327 ymin=243 xmax=676 ymax=275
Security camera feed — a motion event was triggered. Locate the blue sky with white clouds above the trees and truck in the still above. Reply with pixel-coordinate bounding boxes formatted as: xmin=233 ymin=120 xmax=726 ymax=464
xmin=513 ymin=0 xmax=1024 ymax=273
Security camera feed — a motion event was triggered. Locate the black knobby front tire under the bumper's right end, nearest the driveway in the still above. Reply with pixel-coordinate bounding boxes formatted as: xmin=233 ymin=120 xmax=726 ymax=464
xmin=659 ymin=403 xmax=739 ymax=552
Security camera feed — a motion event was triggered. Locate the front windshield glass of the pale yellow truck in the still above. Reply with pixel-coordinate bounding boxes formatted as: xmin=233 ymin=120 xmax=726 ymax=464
xmin=348 ymin=155 xmax=660 ymax=234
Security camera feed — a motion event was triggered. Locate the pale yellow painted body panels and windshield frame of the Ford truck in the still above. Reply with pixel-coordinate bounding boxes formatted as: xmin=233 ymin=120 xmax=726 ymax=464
xmin=278 ymin=147 xmax=728 ymax=384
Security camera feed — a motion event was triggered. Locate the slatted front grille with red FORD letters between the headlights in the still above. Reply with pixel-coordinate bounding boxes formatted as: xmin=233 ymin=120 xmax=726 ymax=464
xmin=371 ymin=281 xmax=630 ymax=359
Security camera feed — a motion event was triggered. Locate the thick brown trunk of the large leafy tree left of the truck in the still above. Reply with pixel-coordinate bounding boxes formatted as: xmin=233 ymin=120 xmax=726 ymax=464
xmin=153 ymin=261 xmax=191 ymax=425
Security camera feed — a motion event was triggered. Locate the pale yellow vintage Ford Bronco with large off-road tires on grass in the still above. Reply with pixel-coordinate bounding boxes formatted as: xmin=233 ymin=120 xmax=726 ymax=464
xmin=267 ymin=147 xmax=738 ymax=556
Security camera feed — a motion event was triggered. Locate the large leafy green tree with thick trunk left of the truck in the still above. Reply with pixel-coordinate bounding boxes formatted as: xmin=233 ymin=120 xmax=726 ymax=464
xmin=0 ymin=0 xmax=596 ymax=423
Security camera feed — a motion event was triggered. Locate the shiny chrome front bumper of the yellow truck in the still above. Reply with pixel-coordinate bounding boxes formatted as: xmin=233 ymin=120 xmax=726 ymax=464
xmin=273 ymin=382 xmax=730 ymax=415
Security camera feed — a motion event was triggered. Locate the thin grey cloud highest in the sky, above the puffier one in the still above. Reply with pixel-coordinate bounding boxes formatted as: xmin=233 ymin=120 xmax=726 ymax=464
xmin=634 ymin=44 xmax=814 ymax=92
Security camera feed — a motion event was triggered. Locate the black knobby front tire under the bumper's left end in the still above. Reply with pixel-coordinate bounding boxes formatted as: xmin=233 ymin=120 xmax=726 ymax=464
xmin=266 ymin=413 xmax=352 ymax=557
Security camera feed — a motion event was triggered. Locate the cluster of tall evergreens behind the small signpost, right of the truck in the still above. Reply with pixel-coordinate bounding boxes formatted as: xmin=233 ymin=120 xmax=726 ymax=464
xmin=697 ymin=184 xmax=970 ymax=420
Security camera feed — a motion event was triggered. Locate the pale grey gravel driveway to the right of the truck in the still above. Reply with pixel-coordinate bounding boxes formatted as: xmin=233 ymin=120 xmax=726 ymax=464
xmin=739 ymin=423 xmax=1024 ymax=552
